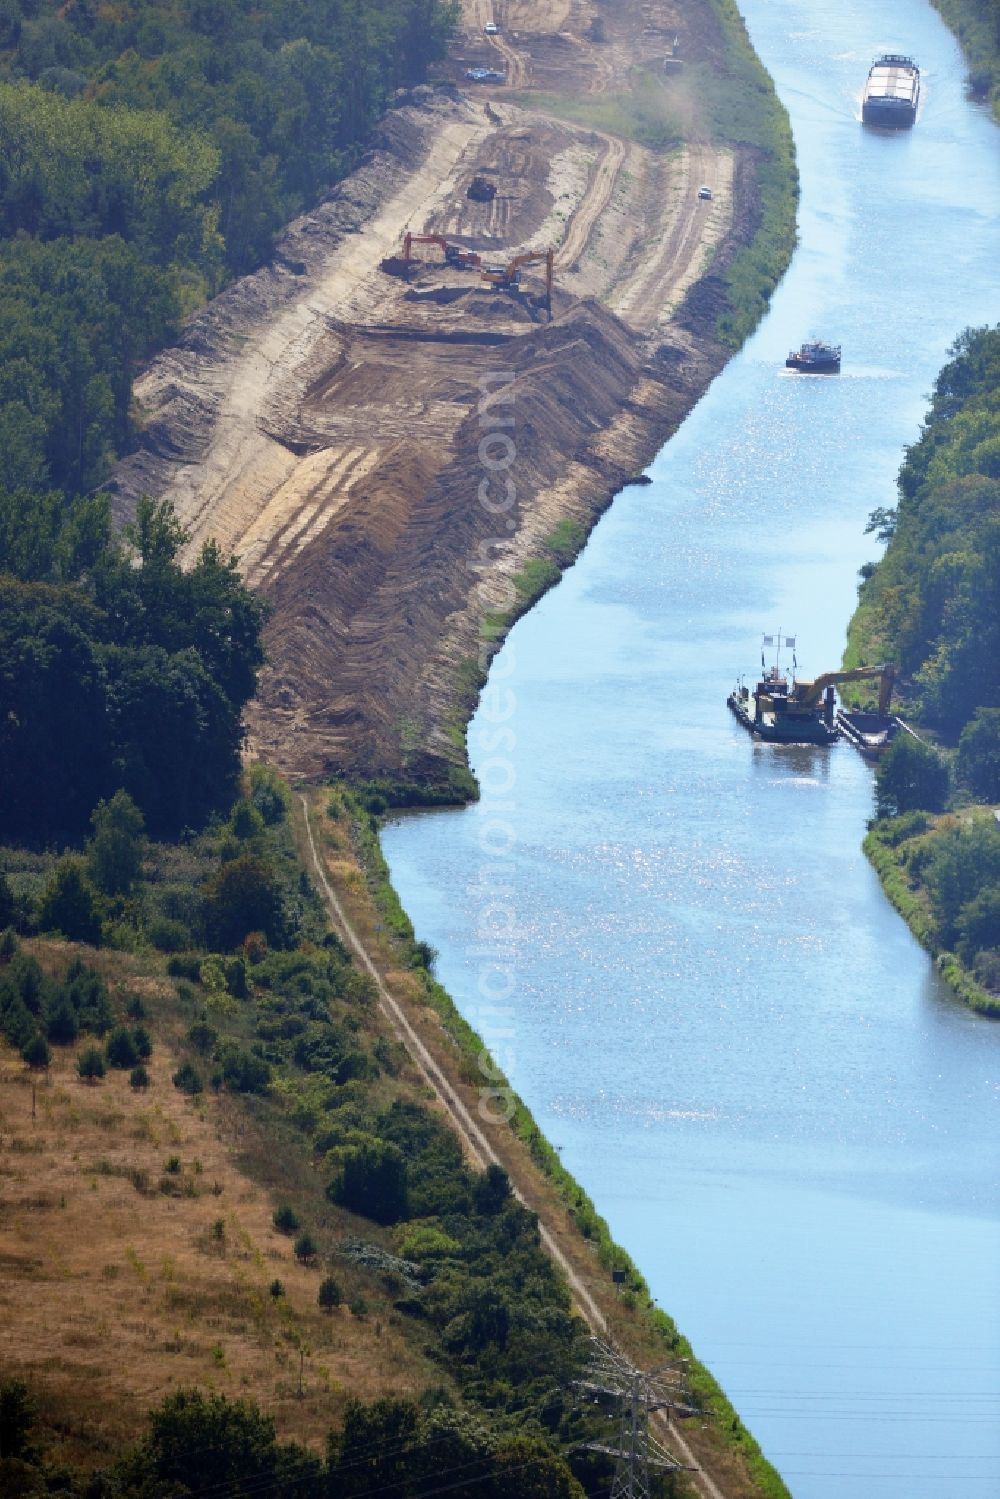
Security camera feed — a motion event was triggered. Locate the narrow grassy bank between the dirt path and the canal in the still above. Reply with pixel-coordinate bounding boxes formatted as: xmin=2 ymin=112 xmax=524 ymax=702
xmin=340 ymin=787 xmax=787 ymax=1499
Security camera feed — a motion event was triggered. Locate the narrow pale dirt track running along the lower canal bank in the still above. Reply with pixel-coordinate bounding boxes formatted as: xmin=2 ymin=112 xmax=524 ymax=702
xmin=300 ymin=793 xmax=726 ymax=1499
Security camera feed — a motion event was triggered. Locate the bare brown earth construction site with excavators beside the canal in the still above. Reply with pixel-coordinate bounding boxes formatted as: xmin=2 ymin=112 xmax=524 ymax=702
xmin=112 ymin=0 xmax=756 ymax=778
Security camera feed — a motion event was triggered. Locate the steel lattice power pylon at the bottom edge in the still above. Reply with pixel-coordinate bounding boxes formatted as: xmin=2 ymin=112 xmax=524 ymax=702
xmin=577 ymin=1337 xmax=697 ymax=1499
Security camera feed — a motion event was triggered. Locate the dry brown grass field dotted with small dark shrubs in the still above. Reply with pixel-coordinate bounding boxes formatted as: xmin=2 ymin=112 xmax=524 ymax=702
xmin=0 ymin=944 xmax=441 ymax=1465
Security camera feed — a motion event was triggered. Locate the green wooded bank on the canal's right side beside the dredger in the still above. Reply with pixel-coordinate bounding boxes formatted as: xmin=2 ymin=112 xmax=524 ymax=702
xmin=844 ymin=327 xmax=1000 ymax=1016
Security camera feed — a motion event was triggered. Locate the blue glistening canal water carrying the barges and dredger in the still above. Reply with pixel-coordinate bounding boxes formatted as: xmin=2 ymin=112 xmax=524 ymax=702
xmin=384 ymin=0 xmax=1000 ymax=1499
